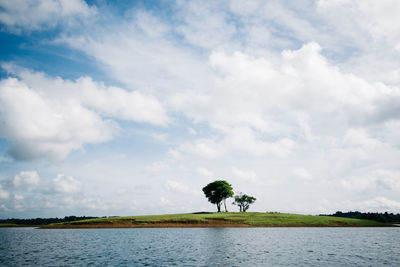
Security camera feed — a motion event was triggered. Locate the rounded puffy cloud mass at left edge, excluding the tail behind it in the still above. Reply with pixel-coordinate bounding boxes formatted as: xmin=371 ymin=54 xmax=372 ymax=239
xmin=0 ymin=78 xmax=115 ymax=159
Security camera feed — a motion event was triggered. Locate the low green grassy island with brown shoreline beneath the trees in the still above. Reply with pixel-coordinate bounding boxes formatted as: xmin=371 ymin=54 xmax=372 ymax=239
xmin=42 ymin=212 xmax=390 ymax=229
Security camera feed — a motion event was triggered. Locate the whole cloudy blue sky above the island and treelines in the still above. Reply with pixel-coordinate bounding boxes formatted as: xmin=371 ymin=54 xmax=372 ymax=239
xmin=0 ymin=0 xmax=400 ymax=218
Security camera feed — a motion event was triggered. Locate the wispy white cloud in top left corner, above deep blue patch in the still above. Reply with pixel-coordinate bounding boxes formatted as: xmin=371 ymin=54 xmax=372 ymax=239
xmin=0 ymin=0 xmax=97 ymax=31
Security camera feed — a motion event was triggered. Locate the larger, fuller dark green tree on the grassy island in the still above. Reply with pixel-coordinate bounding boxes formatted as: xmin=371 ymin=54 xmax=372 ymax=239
xmin=203 ymin=180 xmax=233 ymax=212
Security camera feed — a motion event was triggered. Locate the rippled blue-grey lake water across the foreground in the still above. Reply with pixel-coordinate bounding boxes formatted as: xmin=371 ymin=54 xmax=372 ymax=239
xmin=0 ymin=228 xmax=400 ymax=266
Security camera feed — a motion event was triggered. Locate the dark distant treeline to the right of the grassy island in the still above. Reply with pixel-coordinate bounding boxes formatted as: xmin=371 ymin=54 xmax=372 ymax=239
xmin=321 ymin=211 xmax=400 ymax=223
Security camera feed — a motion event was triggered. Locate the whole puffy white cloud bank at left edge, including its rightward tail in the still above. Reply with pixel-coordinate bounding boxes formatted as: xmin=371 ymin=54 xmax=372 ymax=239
xmin=0 ymin=65 xmax=169 ymax=160
